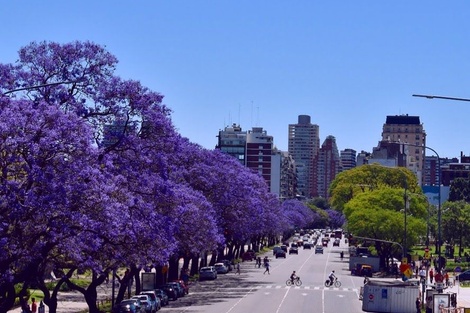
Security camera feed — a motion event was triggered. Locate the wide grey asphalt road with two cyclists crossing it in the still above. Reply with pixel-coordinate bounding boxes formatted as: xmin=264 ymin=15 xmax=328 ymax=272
xmin=161 ymin=236 xmax=363 ymax=313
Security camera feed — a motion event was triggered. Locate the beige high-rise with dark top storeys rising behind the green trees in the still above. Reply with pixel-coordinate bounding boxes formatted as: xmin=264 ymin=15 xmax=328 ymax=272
xmin=382 ymin=114 xmax=426 ymax=184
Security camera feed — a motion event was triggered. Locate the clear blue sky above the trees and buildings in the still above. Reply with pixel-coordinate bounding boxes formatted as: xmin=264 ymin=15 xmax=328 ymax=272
xmin=0 ymin=0 xmax=470 ymax=157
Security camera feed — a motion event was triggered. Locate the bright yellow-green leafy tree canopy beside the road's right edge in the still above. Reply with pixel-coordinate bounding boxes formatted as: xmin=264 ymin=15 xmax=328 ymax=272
xmin=330 ymin=164 xmax=428 ymax=256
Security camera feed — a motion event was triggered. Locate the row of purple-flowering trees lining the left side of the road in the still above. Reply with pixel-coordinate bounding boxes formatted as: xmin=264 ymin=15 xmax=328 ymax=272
xmin=0 ymin=42 xmax=319 ymax=313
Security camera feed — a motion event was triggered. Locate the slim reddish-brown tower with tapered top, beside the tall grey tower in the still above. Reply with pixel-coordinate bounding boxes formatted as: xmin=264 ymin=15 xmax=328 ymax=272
xmin=313 ymin=136 xmax=341 ymax=199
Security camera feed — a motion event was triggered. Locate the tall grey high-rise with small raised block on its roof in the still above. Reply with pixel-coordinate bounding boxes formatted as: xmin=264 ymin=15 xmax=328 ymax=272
xmin=288 ymin=115 xmax=320 ymax=198
